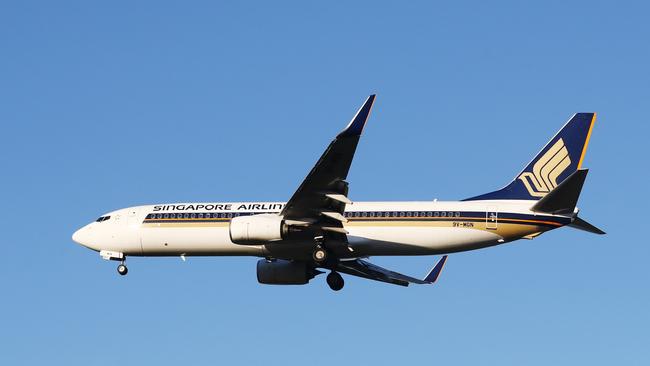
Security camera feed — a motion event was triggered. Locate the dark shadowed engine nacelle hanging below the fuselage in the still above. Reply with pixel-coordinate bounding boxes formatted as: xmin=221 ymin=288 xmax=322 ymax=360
xmin=257 ymin=259 xmax=316 ymax=285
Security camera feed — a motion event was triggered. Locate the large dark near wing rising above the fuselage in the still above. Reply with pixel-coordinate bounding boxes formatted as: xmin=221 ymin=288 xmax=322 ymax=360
xmin=280 ymin=94 xmax=375 ymax=252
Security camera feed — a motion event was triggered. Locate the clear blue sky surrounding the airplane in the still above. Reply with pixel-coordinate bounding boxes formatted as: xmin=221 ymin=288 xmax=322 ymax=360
xmin=0 ymin=1 xmax=650 ymax=365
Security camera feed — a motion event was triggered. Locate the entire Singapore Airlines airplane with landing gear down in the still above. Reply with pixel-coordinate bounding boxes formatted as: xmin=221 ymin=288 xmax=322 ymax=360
xmin=72 ymin=94 xmax=605 ymax=291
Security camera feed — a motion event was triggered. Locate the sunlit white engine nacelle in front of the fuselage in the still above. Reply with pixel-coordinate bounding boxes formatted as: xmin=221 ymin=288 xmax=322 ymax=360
xmin=230 ymin=214 xmax=286 ymax=245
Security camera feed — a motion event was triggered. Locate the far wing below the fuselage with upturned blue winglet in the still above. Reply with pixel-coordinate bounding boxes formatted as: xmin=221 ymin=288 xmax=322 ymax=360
xmin=336 ymin=255 xmax=447 ymax=286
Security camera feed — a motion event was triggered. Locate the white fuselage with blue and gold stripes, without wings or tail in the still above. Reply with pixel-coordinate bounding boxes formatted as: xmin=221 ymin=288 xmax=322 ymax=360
xmin=73 ymin=200 xmax=571 ymax=259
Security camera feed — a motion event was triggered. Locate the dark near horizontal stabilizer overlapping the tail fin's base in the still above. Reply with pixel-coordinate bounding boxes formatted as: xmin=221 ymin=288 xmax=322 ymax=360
xmin=531 ymin=169 xmax=589 ymax=214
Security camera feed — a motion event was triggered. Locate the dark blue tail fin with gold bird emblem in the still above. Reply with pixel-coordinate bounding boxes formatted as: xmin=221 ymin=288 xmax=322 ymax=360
xmin=465 ymin=113 xmax=596 ymax=201
